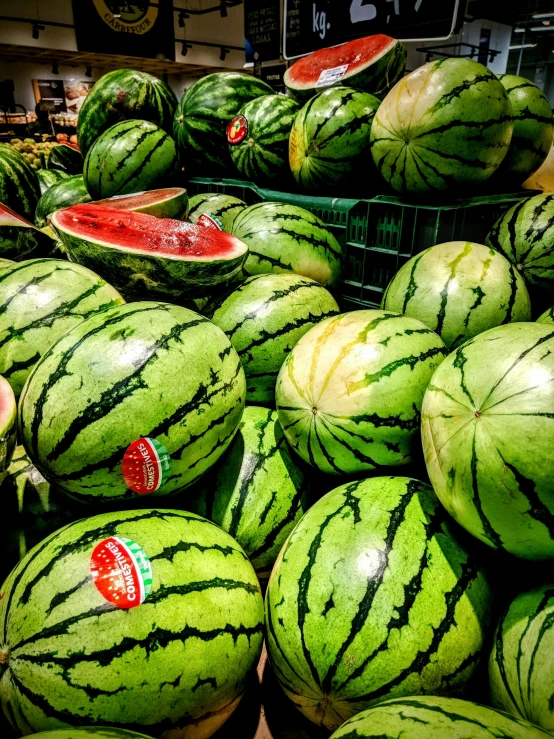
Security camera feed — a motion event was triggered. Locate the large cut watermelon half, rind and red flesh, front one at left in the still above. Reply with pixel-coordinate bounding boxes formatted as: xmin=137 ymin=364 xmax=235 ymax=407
xmin=50 ymin=203 xmax=248 ymax=300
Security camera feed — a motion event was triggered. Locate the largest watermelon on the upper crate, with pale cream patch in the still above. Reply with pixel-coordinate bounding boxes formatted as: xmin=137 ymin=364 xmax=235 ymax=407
xmin=371 ymin=58 xmax=513 ymax=194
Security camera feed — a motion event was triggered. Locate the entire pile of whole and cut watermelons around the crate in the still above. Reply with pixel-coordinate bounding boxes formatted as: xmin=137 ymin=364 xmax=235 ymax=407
xmin=0 ymin=37 xmax=554 ymax=739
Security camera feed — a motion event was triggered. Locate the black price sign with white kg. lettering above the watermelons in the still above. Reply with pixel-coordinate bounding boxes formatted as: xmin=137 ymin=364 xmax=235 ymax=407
xmin=283 ymin=0 xmax=465 ymax=59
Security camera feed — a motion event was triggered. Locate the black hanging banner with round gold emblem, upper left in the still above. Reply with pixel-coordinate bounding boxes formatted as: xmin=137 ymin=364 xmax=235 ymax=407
xmin=73 ymin=0 xmax=175 ymax=60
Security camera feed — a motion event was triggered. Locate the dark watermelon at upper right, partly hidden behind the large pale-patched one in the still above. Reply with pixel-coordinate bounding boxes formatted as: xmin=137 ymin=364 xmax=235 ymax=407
xmin=495 ymin=74 xmax=554 ymax=188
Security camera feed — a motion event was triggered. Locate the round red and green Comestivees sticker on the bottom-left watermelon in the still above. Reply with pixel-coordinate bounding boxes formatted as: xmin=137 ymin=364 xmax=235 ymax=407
xmin=90 ymin=536 xmax=152 ymax=609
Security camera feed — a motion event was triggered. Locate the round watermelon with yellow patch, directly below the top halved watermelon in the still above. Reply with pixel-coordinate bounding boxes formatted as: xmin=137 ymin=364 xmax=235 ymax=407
xmin=290 ymin=87 xmax=380 ymax=190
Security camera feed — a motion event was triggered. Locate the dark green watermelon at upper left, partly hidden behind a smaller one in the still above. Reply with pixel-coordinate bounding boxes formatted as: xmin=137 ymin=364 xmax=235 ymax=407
xmin=77 ymin=69 xmax=177 ymax=156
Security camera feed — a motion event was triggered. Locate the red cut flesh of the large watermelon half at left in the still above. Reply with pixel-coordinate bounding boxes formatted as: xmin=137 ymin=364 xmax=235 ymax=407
xmin=52 ymin=203 xmax=247 ymax=261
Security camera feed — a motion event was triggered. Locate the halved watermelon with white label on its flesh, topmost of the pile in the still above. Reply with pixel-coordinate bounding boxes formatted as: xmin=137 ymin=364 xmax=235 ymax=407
xmin=284 ymin=33 xmax=406 ymax=101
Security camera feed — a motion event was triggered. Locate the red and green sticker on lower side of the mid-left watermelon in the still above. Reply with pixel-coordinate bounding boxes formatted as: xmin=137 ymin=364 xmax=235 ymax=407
xmin=121 ymin=437 xmax=171 ymax=495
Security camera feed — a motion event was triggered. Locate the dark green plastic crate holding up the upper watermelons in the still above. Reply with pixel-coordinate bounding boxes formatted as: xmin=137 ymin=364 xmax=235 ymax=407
xmin=189 ymin=177 xmax=533 ymax=310
